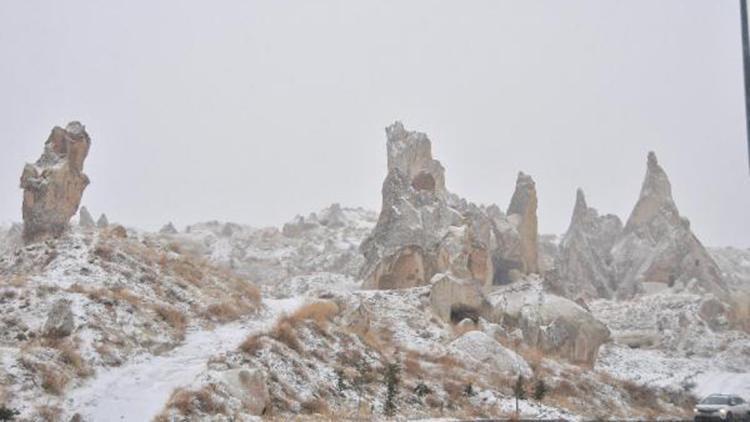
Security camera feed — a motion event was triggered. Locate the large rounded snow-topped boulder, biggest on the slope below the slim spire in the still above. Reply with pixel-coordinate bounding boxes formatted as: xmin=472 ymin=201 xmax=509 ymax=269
xmin=489 ymin=282 xmax=610 ymax=365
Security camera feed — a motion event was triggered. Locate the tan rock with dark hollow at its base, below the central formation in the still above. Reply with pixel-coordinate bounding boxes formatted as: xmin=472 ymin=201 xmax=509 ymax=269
xmin=430 ymin=274 xmax=491 ymax=322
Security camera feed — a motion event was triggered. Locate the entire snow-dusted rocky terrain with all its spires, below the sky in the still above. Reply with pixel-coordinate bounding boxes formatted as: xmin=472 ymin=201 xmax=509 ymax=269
xmin=0 ymin=122 xmax=750 ymax=421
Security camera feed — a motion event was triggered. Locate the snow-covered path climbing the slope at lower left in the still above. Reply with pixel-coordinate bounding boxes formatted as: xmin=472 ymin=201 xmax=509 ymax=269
xmin=66 ymin=298 xmax=301 ymax=422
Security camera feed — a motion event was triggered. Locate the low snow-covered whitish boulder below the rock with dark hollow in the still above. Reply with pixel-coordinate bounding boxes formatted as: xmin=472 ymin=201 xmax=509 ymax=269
xmin=448 ymin=331 xmax=532 ymax=377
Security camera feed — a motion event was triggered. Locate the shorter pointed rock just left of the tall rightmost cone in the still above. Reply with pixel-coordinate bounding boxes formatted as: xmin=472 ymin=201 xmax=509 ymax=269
xmin=555 ymin=189 xmax=622 ymax=299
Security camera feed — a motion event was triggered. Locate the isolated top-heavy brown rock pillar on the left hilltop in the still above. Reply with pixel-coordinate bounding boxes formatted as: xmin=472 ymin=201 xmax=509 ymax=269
xmin=21 ymin=122 xmax=91 ymax=243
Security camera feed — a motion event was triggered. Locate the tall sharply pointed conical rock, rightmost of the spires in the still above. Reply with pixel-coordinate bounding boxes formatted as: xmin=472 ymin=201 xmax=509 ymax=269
xmin=612 ymin=152 xmax=727 ymax=298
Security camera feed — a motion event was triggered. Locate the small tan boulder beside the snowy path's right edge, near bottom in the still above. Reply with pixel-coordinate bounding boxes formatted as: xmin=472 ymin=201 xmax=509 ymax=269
xmin=222 ymin=368 xmax=271 ymax=416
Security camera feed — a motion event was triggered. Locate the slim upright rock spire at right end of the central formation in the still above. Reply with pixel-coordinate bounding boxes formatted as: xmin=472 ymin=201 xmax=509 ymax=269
xmin=508 ymin=172 xmax=539 ymax=274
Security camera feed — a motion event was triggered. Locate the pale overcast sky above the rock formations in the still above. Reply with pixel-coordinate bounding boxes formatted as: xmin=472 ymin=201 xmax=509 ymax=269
xmin=0 ymin=0 xmax=750 ymax=247
